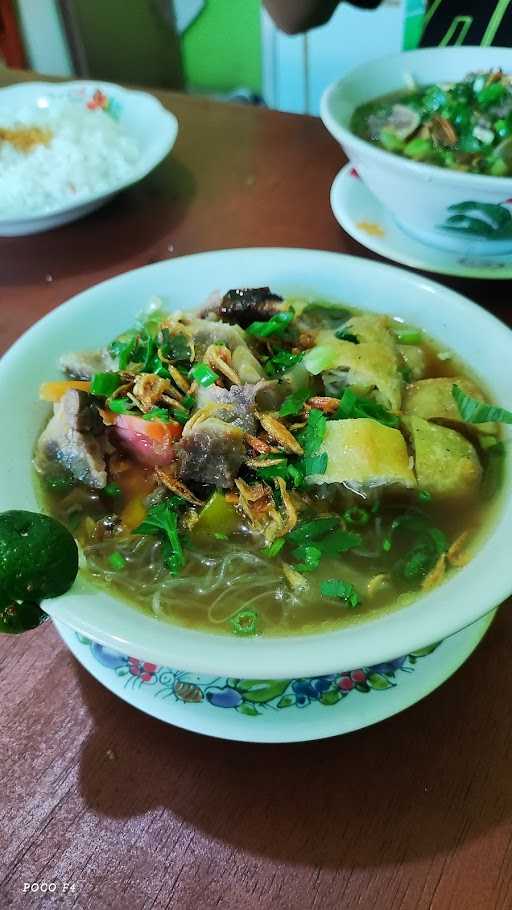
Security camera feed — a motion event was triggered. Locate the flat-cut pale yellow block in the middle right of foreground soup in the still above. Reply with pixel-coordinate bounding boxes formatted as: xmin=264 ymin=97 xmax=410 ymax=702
xmin=308 ymin=417 xmax=416 ymax=492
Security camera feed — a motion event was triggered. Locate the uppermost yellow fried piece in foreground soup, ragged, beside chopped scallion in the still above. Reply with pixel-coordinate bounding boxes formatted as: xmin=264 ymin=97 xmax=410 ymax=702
xmin=303 ymin=332 xmax=402 ymax=411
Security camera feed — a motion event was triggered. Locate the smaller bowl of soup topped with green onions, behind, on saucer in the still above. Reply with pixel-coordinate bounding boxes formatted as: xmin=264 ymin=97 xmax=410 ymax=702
xmin=321 ymin=47 xmax=512 ymax=256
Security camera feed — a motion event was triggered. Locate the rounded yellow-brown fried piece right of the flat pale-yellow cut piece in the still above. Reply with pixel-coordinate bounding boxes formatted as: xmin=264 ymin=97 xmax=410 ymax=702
xmin=403 ymin=417 xmax=482 ymax=500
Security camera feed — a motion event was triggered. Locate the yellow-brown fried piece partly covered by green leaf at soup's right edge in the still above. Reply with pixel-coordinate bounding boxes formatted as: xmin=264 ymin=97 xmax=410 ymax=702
xmin=403 ymin=376 xmax=496 ymax=435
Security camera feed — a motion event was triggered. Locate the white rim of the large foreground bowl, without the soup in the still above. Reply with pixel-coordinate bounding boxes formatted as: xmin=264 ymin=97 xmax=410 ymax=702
xmin=0 ymin=249 xmax=512 ymax=679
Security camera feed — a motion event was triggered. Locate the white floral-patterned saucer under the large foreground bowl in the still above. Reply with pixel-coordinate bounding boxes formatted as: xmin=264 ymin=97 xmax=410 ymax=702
xmin=54 ymin=611 xmax=495 ymax=743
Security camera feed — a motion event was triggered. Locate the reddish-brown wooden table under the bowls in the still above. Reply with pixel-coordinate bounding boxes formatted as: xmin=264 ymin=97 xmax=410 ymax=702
xmin=0 ymin=74 xmax=512 ymax=910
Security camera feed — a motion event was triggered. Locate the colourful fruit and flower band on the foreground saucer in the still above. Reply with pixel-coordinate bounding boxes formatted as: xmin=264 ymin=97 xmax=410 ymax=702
xmin=76 ymin=634 xmax=438 ymax=717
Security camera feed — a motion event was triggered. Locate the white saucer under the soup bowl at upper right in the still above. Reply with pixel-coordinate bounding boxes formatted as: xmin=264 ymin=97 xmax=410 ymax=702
xmin=331 ymin=162 xmax=512 ymax=279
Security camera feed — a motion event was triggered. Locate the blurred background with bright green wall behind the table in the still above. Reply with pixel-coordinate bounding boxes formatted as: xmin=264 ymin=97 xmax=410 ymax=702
xmin=0 ymin=0 xmax=408 ymax=114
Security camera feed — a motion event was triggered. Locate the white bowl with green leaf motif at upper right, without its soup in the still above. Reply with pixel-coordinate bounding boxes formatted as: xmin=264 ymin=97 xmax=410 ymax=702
xmin=321 ymin=47 xmax=512 ymax=256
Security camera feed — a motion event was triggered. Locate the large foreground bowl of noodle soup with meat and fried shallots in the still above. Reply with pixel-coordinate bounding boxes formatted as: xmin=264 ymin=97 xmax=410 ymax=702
xmin=0 ymin=249 xmax=512 ymax=679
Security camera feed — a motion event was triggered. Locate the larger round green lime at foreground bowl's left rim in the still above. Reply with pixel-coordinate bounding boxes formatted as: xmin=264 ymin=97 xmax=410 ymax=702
xmin=0 ymin=511 xmax=78 ymax=604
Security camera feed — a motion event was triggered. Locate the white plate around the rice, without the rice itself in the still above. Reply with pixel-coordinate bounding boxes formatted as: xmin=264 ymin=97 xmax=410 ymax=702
xmin=0 ymin=80 xmax=178 ymax=237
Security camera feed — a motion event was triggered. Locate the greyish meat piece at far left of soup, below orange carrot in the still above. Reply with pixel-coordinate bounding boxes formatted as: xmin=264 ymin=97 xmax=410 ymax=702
xmin=34 ymin=389 xmax=107 ymax=490
